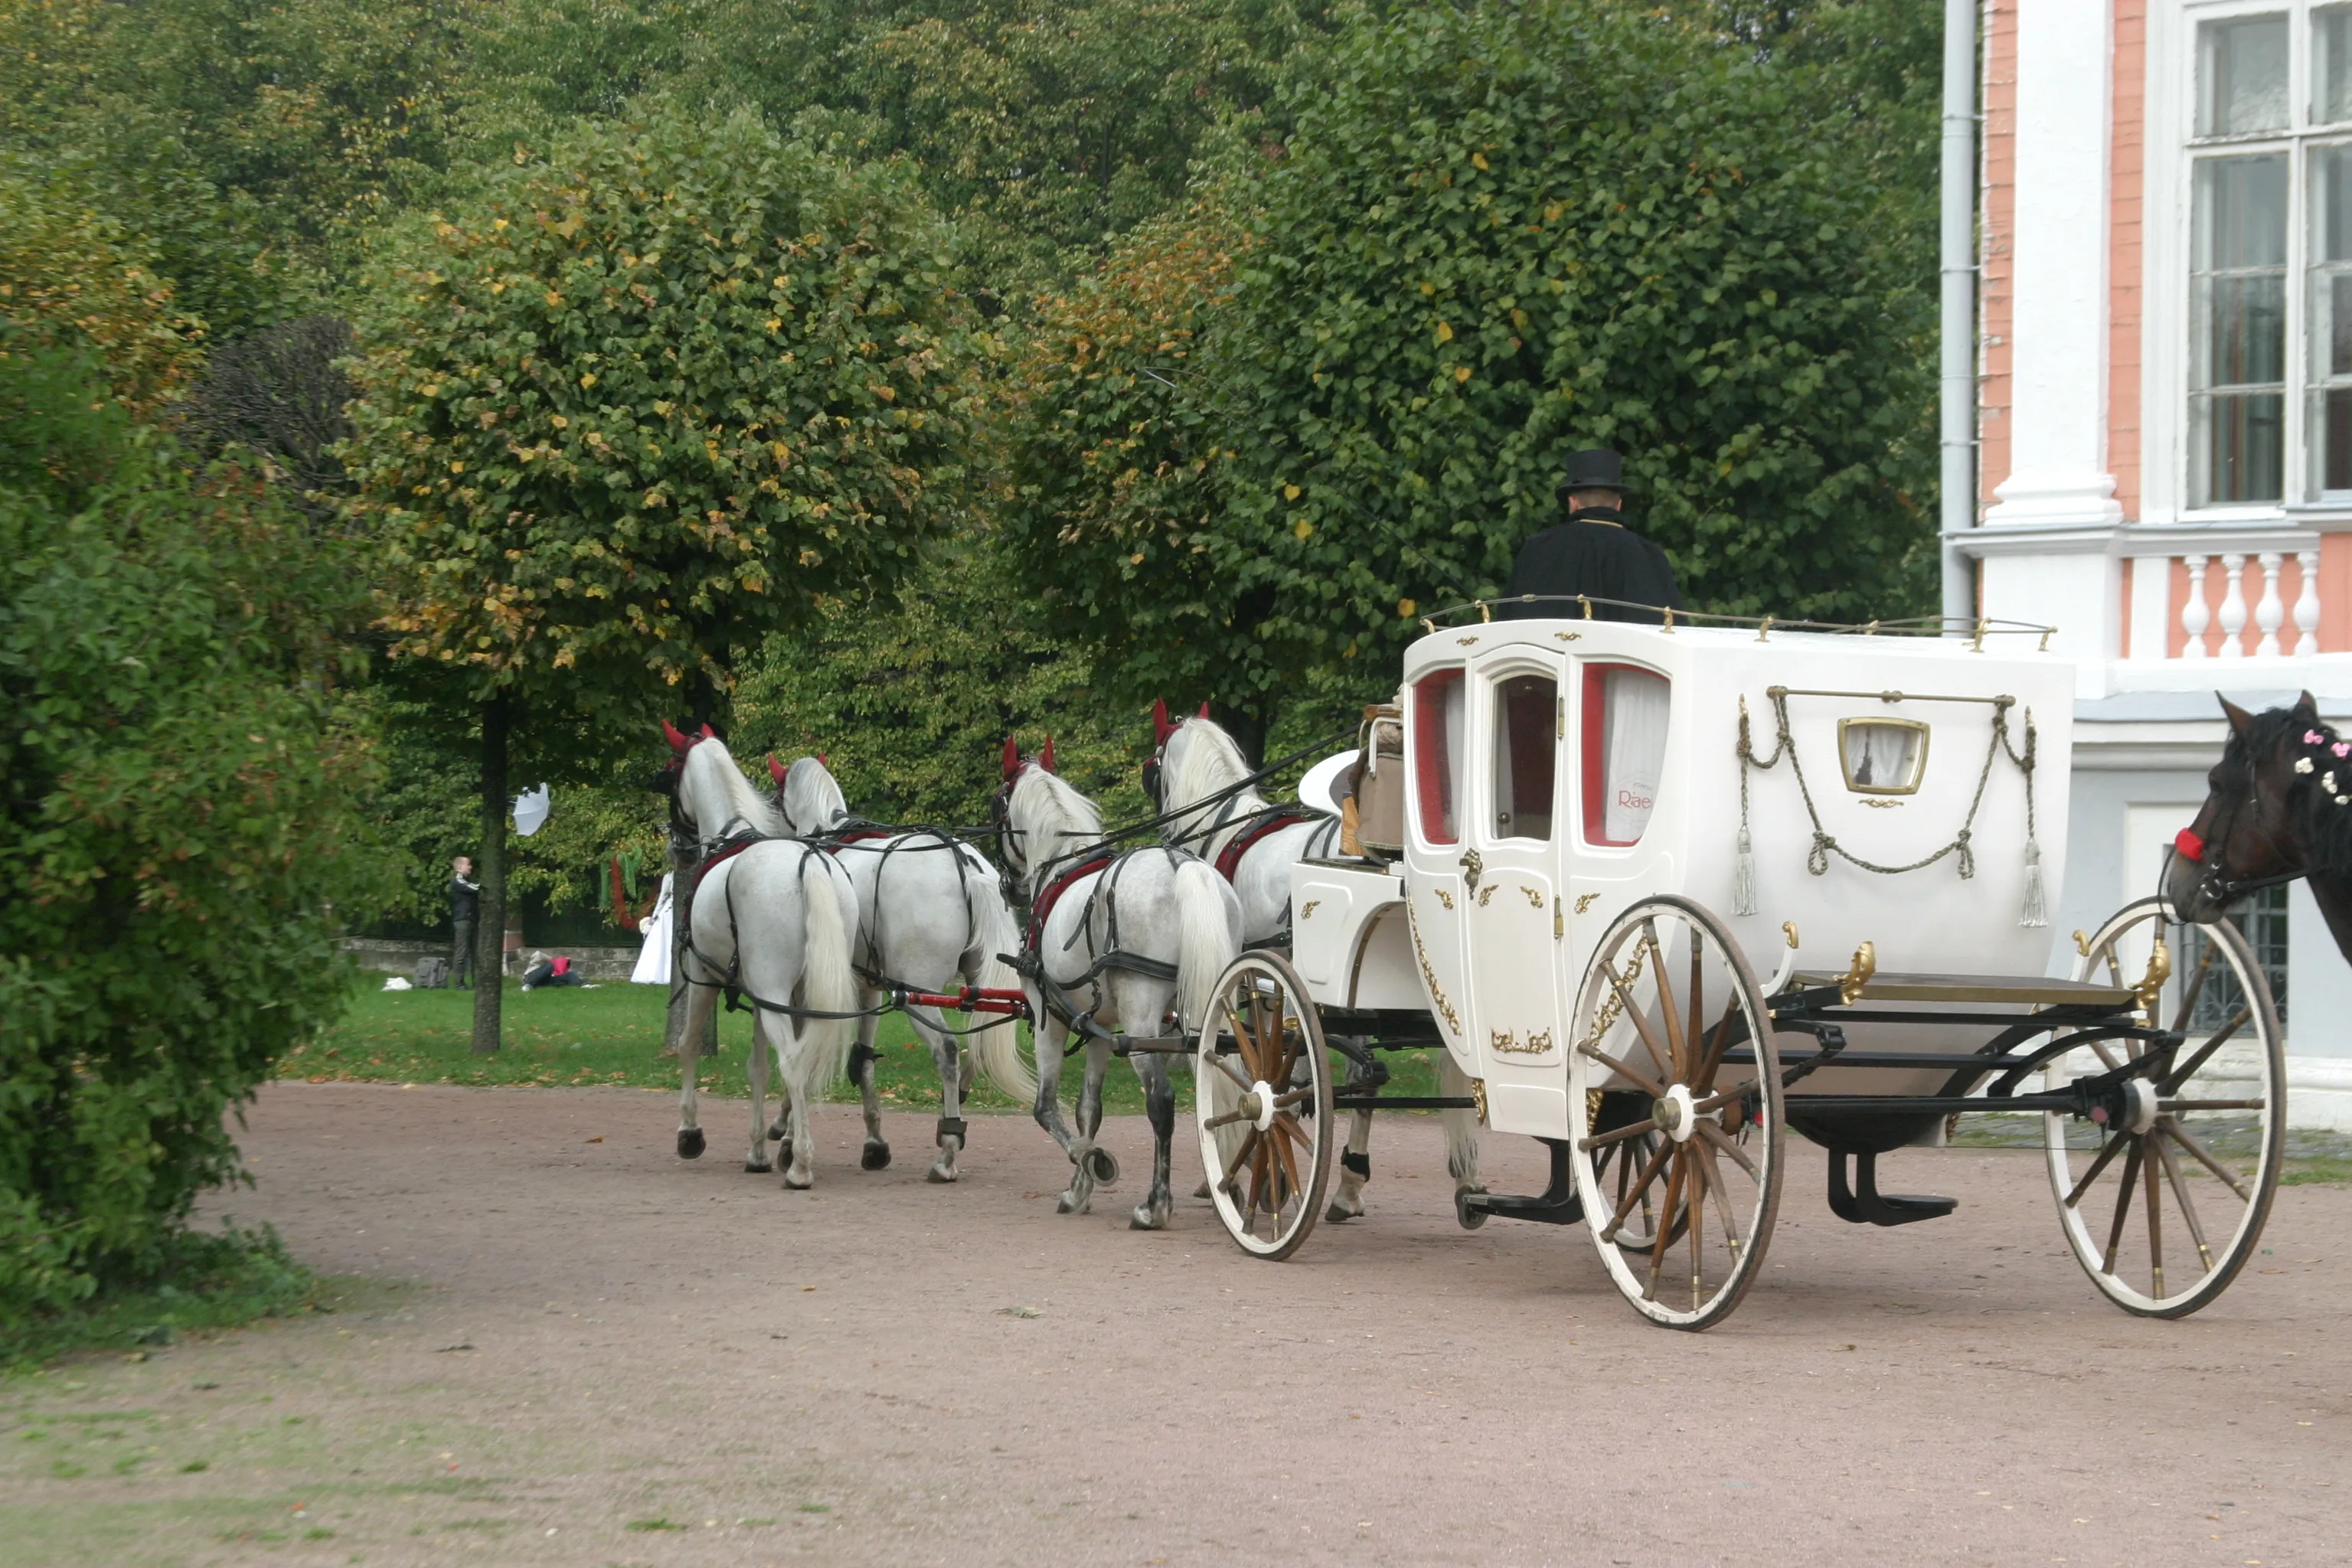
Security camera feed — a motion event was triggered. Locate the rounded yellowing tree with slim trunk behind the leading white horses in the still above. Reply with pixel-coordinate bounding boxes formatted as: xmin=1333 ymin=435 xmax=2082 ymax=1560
xmin=348 ymin=113 xmax=972 ymax=1050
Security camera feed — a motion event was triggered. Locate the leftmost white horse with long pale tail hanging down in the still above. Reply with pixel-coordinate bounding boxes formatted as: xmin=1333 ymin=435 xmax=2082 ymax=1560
xmin=661 ymin=724 xmax=858 ymax=1190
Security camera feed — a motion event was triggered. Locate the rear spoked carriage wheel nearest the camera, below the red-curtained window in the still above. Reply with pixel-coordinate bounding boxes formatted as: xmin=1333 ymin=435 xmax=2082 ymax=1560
xmin=1569 ymin=896 xmax=1785 ymax=1328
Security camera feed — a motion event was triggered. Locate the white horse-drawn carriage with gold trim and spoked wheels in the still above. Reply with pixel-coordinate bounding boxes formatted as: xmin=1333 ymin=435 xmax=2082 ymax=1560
xmin=1195 ymin=602 xmax=2284 ymax=1328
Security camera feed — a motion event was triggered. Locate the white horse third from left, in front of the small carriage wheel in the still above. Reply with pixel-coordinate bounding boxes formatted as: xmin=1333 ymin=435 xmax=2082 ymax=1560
xmin=998 ymin=740 xmax=1242 ymax=1230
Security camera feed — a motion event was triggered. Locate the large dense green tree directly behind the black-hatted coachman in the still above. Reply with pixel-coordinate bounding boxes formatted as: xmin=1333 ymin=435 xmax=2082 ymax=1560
xmin=1007 ymin=0 xmax=1933 ymax=743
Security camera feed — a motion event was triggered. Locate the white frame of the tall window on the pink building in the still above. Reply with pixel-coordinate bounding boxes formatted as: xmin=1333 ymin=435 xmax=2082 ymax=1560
xmin=2141 ymin=0 xmax=2352 ymax=522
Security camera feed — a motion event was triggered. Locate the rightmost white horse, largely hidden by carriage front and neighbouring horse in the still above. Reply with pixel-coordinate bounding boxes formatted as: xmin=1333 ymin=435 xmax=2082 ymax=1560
xmin=1145 ymin=703 xmax=1487 ymax=1220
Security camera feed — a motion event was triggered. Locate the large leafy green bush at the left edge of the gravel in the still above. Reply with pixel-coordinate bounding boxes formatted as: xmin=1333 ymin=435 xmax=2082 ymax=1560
xmin=0 ymin=343 xmax=369 ymax=1321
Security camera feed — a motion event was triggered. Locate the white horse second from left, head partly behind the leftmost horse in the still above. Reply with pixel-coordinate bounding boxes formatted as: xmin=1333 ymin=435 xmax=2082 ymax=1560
xmin=766 ymin=757 xmax=1037 ymax=1182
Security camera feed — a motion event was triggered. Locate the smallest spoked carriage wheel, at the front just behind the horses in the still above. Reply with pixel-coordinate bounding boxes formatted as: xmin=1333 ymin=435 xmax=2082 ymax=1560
xmin=1193 ymin=952 xmax=1334 ymax=1258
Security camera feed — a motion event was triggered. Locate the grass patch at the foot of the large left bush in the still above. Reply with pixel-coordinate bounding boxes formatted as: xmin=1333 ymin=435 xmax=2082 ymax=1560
xmin=0 ymin=1230 xmax=325 ymax=1373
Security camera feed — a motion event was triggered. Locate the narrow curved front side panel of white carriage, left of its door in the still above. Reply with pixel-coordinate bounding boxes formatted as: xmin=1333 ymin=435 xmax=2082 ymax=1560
xmin=1404 ymin=665 xmax=1477 ymax=1076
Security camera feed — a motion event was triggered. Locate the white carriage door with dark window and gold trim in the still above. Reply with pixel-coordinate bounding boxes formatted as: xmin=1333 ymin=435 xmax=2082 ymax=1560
xmin=1463 ymin=656 xmax=1566 ymax=1135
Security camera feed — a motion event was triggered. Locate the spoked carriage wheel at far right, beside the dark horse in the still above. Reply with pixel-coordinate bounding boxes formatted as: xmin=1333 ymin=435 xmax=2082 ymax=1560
xmin=2041 ymin=898 xmax=2286 ymax=1316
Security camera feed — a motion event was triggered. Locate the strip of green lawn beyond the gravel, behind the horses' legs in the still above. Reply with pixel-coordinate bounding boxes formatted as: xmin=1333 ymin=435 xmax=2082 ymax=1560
xmin=277 ymin=975 xmax=1437 ymax=1114
